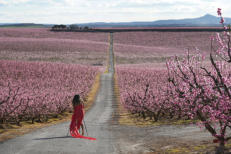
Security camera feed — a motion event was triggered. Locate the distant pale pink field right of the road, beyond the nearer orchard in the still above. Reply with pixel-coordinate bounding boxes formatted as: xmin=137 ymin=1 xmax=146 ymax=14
xmin=114 ymin=32 xmax=215 ymax=64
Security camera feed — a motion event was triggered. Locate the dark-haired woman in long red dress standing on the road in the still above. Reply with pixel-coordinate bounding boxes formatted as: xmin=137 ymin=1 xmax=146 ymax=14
xmin=70 ymin=95 xmax=96 ymax=140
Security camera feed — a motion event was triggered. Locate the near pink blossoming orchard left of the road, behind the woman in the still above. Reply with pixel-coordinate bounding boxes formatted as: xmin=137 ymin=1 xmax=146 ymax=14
xmin=0 ymin=60 xmax=98 ymax=124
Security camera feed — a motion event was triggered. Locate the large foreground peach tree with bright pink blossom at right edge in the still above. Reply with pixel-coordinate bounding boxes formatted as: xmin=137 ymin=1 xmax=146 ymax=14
xmin=167 ymin=9 xmax=231 ymax=151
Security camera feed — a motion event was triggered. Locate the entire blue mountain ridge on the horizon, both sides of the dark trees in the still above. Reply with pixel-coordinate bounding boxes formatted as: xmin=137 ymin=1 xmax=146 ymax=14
xmin=0 ymin=14 xmax=231 ymax=28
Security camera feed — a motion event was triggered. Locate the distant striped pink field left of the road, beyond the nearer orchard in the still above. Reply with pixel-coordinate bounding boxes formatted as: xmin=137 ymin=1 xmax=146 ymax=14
xmin=0 ymin=28 xmax=108 ymax=65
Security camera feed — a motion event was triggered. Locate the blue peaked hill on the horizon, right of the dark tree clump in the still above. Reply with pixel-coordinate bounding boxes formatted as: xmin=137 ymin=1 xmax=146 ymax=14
xmin=77 ymin=14 xmax=231 ymax=28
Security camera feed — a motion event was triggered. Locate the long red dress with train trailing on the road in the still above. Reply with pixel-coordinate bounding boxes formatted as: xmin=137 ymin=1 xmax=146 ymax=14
xmin=70 ymin=104 xmax=96 ymax=140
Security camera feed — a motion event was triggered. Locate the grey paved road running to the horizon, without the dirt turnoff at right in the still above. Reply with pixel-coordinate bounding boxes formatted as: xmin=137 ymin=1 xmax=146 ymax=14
xmin=0 ymin=34 xmax=116 ymax=154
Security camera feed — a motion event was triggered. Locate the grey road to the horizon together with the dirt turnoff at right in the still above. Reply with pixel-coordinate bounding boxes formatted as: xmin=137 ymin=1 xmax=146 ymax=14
xmin=0 ymin=33 xmax=210 ymax=154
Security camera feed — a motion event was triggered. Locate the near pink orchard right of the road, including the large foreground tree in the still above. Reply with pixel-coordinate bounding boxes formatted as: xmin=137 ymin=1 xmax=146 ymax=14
xmin=117 ymin=9 xmax=231 ymax=149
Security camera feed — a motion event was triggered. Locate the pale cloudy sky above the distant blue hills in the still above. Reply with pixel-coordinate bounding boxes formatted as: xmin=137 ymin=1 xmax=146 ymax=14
xmin=0 ymin=0 xmax=231 ymax=24
